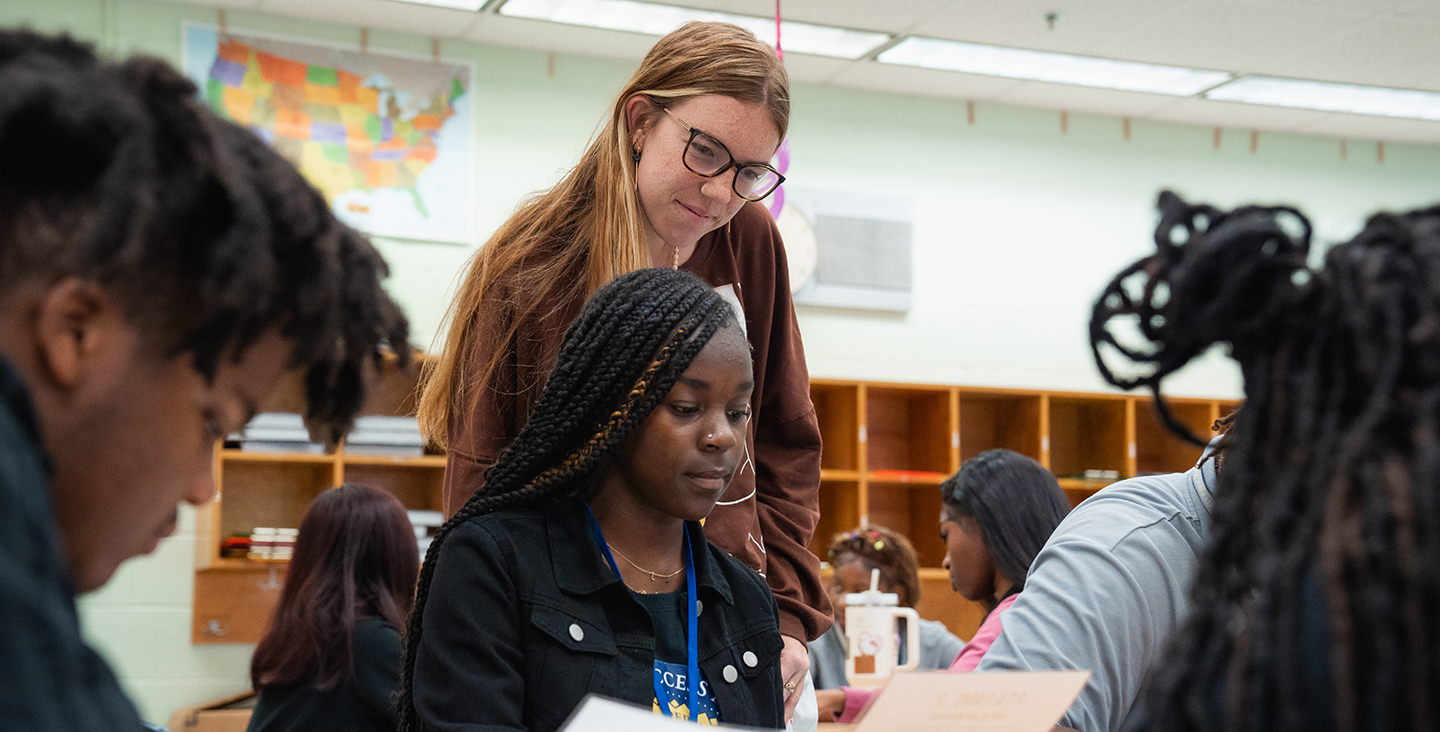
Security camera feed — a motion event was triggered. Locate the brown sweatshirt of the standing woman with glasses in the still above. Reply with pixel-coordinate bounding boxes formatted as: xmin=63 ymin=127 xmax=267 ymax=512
xmin=445 ymin=203 xmax=831 ymax=641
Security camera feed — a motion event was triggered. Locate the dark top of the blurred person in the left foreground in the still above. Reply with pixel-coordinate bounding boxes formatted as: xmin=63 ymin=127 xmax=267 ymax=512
xmin=0 ymin=359 xmax=143 ymax=732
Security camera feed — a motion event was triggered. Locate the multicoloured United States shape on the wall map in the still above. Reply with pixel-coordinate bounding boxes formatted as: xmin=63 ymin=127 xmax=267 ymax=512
xmin=204 ymin=40 xmax=465 ymax=216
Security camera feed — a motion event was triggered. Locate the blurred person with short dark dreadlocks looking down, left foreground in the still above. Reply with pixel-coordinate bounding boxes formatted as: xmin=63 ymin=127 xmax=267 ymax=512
xmin=0 ymin=30 xmax=409 ymax=732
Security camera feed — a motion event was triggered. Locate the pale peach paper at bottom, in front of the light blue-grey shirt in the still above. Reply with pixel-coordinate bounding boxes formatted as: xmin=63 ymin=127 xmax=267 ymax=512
xmin=855 ymin=671 xmax=1090 ymax=732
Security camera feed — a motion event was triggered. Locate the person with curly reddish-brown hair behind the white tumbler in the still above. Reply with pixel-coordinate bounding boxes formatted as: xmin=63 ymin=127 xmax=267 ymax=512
xmin=809 ymin=526 xmax=965 ymax=697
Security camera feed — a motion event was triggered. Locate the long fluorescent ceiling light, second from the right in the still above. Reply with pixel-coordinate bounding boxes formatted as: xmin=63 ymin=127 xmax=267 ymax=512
xmin=878 ymin=37 xmax=1231 ymax=97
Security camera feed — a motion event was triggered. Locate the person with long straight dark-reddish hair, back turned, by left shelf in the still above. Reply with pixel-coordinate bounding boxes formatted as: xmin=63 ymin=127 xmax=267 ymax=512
xmin=249 ymin=484 xmax=420 ymax=732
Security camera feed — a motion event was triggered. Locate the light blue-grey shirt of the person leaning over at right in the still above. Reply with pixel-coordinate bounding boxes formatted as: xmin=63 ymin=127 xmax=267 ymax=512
xmin=976 ymin=460 xmax=1215 ymax=732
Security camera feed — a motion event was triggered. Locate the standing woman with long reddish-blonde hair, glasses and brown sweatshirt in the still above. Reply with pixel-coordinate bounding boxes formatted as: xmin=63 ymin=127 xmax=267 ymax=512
xmin=419 ymin=23 xmax=831 ymax=714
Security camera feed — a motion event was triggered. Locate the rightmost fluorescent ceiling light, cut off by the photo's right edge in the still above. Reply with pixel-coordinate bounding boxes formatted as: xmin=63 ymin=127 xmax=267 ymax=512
xmin=1205 ymin=76 xmax=1440 ymax=121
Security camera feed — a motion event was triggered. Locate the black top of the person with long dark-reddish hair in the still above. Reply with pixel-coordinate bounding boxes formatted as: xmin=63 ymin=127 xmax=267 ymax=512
xmin=248 ymin=618 xmax=400 ymax=732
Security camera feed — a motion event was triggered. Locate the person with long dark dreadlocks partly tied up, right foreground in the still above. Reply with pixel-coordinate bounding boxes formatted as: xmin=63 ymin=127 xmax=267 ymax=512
xmin=1092 ymin=195 xmax=1440 ymax=732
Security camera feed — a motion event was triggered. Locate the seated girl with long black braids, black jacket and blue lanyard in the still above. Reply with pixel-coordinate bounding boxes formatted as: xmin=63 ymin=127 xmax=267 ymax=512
xmin=400 ymin=269 xmax=783 ymax=732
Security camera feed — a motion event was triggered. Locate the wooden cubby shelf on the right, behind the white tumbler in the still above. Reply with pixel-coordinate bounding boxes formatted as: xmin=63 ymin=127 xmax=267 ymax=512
xmin=811 ymin=379 xmax=1237 ymax=638
